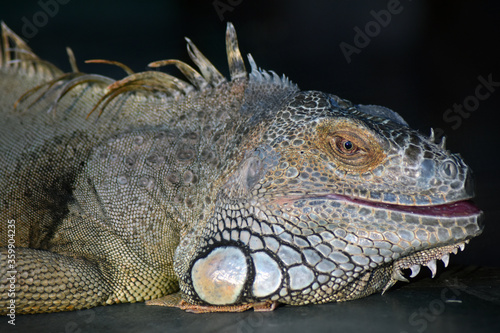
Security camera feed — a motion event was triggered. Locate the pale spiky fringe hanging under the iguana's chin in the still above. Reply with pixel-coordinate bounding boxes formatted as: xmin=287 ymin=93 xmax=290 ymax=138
xmin=382 ymin=240 xmax=469 ymax=294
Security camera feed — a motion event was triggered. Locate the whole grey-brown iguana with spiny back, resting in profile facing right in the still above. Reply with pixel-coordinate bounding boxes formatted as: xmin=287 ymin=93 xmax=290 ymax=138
xmin=0 ymin=24 xmax=483 ymax=314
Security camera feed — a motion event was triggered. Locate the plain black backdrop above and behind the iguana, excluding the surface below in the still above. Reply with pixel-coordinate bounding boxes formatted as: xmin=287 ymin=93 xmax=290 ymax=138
xmin=0 ymin=0 xmax=500 ymax=266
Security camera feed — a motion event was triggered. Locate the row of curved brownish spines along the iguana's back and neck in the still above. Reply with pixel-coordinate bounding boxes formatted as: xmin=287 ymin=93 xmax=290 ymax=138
xmin=0 ymin=23 xmax=297 ymax=116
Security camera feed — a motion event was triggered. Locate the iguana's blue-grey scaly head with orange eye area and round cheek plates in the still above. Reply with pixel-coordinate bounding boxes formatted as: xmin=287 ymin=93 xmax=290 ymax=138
xmin=176 ymin=24 xmax=483 ymax=305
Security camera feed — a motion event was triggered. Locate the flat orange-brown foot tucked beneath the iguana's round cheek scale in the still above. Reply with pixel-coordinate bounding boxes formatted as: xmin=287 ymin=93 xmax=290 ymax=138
xmin=146 ymin=292 xmax=278 ymax=313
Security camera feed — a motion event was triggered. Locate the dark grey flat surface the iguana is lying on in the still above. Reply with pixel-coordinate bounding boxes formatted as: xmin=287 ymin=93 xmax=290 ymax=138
xmin=0 ymin=266 xmax=500 ymax=333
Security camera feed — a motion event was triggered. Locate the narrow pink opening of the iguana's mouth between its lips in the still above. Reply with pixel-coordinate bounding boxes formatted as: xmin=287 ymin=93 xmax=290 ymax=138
xmin=324 ymin=194 xmax=481 ymax=217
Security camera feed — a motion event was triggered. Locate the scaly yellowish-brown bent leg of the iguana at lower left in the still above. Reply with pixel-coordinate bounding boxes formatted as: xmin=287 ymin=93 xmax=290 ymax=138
xmin=0 ymin=248 xmax=111 ymax=315
